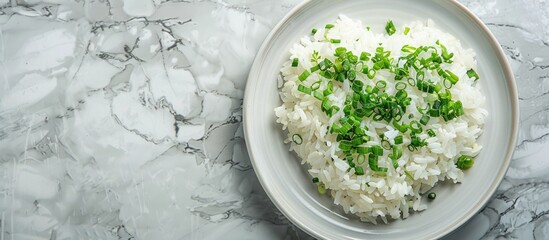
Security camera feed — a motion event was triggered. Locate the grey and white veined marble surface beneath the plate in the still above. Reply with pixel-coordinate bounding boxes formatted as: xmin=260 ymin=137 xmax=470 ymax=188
xmin=0 ymin=0 xmax=549 ymax=240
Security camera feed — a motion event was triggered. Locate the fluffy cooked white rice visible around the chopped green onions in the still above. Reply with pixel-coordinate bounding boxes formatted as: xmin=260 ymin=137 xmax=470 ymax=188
xmin=275 ymin=16 xmax=487 ymax=223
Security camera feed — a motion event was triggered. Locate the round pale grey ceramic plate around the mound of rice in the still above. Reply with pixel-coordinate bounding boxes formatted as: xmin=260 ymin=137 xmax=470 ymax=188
xmin=244 ymin=0 xmax=518 ymax=239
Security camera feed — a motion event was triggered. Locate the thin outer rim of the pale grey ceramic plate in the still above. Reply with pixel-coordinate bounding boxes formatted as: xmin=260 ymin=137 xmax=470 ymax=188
xmin=243 ymin=0 xmax=519 ymax=239
